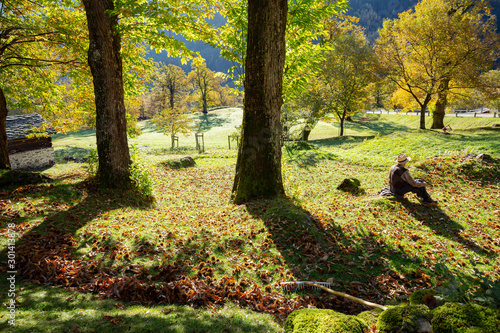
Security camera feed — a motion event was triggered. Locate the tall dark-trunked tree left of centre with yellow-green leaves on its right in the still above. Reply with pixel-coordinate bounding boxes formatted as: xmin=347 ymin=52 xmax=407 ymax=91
xmin=83 ymin=0 xmax=213 ymax=187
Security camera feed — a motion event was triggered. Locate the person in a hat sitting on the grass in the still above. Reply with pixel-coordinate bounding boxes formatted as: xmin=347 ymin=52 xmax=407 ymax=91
xmin=389 ymin=154 xmax=437 ymax=203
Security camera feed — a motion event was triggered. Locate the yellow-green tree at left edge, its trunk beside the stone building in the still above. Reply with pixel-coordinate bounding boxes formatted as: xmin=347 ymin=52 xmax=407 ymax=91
xmin=0 ymin=0 xmax=83 ymax=169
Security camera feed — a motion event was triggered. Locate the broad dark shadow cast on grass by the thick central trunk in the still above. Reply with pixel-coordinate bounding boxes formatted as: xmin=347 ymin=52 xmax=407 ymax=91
xmin=240 ymin=199 xmax=431 ymax=313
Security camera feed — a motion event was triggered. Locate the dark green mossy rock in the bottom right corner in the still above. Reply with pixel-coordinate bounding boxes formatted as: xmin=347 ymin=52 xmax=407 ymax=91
xmin=431 ymin=303 xmax=500 ymax=333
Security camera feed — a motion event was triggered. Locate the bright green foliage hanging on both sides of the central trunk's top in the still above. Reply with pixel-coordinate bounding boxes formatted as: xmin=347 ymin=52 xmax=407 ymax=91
xmin=214 ymin=0 xmax=347 ymax=95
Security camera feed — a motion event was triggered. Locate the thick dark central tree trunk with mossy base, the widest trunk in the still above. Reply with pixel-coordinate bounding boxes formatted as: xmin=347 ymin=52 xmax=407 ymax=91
xmin=232 ymin=0 xmax=288 ymax=203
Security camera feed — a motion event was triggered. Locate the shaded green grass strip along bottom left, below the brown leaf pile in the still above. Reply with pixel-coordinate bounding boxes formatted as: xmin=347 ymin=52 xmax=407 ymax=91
xmin=0 ymin=273 xmax=279 ymax=333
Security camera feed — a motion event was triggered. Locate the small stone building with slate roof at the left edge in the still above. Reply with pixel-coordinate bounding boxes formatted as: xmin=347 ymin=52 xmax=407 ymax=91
xmin=6 ymin=113 xmax=56 ymax=170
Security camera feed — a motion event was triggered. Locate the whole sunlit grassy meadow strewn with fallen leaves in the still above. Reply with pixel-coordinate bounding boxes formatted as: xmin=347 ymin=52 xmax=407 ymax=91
xmin=0 ymin=109 xmax=500 ymax=332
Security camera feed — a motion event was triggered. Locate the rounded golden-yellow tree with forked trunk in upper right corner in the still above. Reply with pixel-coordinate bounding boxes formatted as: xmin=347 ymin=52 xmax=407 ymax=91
xmin=375 ymin=0 xmax=498 ymax=129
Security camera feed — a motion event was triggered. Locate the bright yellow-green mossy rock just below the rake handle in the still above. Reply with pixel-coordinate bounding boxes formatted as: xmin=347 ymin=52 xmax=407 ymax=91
xmin=285 ymin=309 xmax=368 ymax=333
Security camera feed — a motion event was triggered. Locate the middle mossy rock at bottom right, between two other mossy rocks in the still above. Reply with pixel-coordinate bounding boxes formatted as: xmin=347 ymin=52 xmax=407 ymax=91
xmin=377 ymin=305 xmax=433 ymax=333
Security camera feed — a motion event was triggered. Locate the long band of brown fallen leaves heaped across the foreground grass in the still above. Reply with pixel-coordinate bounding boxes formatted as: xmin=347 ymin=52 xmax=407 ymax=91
xmin=17 ymin=223 xmax=368 ymax=320
